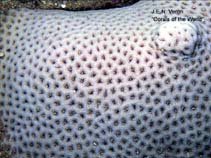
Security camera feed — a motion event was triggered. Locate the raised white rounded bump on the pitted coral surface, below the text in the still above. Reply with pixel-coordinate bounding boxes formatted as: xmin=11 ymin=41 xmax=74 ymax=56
xmin=154 ymin=22 xmax=198 ymax=55
